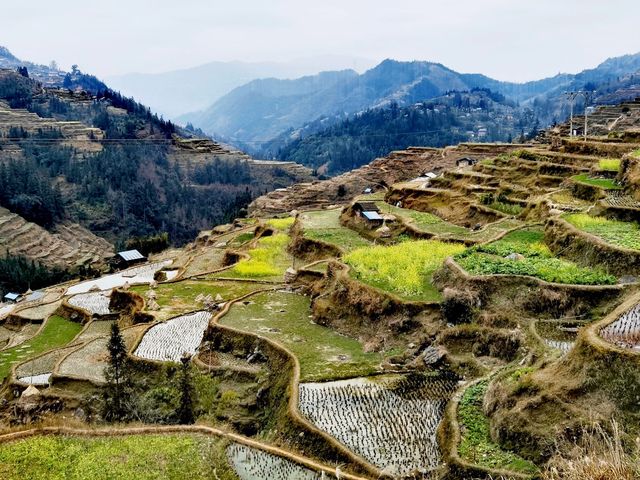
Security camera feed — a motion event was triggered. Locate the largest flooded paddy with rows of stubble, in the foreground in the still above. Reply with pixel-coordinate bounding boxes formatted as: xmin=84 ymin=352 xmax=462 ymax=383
xmin=299 ymin=377 xmax=456 ymax=475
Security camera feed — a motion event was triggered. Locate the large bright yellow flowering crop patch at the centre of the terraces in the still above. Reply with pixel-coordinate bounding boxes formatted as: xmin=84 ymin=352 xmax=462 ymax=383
xmin=344 ymin=240 xmax=465 ymax=301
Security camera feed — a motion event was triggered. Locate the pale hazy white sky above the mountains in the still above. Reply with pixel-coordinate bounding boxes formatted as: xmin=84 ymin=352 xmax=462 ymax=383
xmin=5 ymin=0 xmax=640 ymax=81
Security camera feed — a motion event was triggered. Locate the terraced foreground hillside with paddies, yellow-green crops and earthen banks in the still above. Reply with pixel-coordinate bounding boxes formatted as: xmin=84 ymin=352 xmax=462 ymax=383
xmin=0 ymin=101 xmax=640 ymax=480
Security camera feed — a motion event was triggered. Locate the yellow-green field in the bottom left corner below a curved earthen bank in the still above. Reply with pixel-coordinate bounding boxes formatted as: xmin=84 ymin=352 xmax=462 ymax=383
xmin=0 ymin=434 xmax=238 ymax=480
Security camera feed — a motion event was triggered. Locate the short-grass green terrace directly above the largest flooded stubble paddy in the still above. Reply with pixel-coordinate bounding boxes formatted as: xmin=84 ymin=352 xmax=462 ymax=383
xmin=220 ymin=292 xmax=382 ymax=381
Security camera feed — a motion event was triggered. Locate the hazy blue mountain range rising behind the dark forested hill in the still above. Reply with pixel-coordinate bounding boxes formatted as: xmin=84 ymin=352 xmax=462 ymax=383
xmin=177 ymin=54 xmax=640 ymax=155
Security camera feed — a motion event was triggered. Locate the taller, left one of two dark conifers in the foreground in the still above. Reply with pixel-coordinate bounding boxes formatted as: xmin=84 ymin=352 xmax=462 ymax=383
xmin=103 ymin=323 xmax=131 ymax=421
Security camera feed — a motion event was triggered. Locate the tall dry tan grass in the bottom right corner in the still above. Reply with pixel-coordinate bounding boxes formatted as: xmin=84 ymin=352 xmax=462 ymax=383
xmin=542 ymin=421 xmax=640 ymax=480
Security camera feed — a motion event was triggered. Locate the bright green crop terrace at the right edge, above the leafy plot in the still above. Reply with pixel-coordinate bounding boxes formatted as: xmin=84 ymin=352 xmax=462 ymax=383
xmin=564 ymin=213 xmax=640 ymax=250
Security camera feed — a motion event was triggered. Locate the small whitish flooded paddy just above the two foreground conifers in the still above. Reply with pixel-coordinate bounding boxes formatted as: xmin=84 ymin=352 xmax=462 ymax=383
xmin=135 ymin=312 xmax=211 ymax=362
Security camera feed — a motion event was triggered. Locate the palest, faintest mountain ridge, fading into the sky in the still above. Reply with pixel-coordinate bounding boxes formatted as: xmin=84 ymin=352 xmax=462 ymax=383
xmin=105 ymin=55 xmax=375 ymax=118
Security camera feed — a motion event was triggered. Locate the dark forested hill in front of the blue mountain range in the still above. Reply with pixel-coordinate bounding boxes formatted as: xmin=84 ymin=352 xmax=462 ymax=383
xmin=272 ymin=89 xmax=539 ymax=175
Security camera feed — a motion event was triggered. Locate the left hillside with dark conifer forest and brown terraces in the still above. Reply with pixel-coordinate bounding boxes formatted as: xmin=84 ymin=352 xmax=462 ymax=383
xmin=0 ymin=69 xmax=311 ymax=288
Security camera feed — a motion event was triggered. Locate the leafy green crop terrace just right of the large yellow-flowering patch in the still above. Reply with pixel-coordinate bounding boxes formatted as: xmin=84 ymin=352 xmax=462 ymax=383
xmin=455 ymin=229 xmax=617 ymax=285
